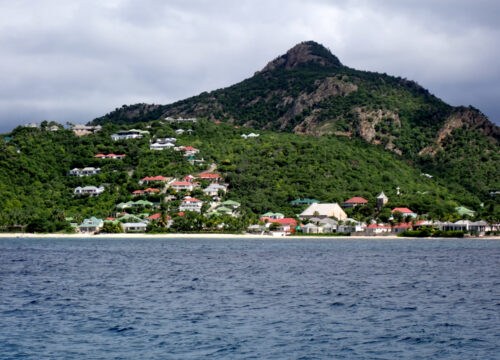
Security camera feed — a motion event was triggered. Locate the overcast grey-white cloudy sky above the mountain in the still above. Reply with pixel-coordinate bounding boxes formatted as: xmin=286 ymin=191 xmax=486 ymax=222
xmin=0 ymin=0 xmax=500 ymax=132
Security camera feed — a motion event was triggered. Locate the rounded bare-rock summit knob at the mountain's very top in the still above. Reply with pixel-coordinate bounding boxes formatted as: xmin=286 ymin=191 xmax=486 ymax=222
xmin=262 ymin=41 xmax=342 ymax=71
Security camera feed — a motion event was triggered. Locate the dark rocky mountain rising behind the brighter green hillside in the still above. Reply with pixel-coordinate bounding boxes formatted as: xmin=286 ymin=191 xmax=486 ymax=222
xmin=93 ymin=41 xmax=500 ymax=197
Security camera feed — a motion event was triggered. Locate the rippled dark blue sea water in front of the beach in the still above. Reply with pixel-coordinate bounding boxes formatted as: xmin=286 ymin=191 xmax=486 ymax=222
xmin=0 ymin=238 xmax=500 ymax=359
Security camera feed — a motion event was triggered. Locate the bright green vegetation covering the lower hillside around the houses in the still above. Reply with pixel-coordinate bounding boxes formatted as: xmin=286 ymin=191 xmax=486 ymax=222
xmin=0 ymin=116 xmax=500 ymax=232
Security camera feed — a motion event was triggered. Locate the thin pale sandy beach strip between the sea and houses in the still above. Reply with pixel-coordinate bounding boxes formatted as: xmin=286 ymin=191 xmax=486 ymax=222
xmin=0 ymin=233 xmax=500 ymax=240
